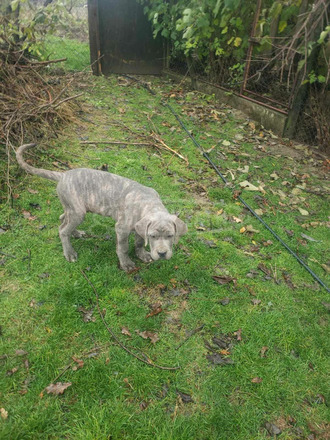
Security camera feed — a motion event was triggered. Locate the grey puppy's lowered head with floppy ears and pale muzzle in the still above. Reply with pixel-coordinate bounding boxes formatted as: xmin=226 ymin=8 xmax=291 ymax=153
xmin=135 ymin=212 xmax=188 ymax=261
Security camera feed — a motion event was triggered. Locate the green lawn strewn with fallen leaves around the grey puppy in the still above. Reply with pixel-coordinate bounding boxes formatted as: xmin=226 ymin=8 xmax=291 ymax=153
xmin=0 ymin=73 xmax=329 ymax=440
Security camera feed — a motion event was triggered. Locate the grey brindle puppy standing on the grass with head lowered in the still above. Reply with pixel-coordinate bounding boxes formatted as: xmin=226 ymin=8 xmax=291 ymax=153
xmin=16 ymin=144 xmax=187 ymax=271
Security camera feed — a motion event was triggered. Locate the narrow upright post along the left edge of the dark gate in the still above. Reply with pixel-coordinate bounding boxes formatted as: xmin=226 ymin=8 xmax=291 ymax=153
xmin=88 ymin=0 xmax=102 ymax=75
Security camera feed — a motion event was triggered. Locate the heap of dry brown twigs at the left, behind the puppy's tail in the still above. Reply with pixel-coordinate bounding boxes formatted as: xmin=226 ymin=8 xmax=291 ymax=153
xmin=0 ymin=42 xmax=81 ymax=196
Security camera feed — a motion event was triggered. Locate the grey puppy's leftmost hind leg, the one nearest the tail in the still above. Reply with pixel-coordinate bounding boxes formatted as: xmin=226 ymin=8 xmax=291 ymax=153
xmin=59 ymin=210 xmax=85 ymax=262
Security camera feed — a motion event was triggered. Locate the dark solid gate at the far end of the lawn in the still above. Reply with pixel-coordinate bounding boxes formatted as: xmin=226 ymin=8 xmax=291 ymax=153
xmin=88 ymin=0 xmax=163 ymax=75
